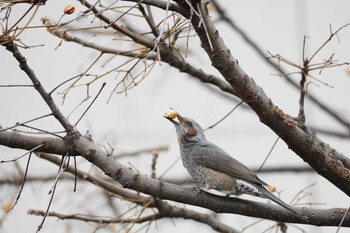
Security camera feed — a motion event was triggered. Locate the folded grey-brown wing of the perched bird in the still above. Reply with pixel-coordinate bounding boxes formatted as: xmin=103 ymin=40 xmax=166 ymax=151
xmin=190 ymin=143 xmax=267 ymax=186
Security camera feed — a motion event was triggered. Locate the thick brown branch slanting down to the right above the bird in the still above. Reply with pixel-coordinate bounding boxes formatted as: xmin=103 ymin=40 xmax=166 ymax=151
xmin=179 ymin=0 xmax=350 ymax=196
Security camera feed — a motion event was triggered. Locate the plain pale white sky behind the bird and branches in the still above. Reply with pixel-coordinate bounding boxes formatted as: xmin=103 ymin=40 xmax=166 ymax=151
xmin=0 ymin=0 xmax=350 ymax=233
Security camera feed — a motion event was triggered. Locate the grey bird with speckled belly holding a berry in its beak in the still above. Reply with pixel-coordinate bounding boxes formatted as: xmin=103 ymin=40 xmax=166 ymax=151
xmin=164 ymin=110 xmax=301 ymax=216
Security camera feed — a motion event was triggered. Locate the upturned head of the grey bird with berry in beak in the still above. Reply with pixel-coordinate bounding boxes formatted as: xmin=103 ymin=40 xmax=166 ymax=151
xmin=164 ymin=109 xmax=205 ymax=143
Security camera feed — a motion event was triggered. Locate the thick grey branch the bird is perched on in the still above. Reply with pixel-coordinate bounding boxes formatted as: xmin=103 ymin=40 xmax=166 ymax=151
xmin=0 ymin=129 xmax=350 ymax=227
